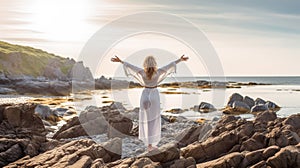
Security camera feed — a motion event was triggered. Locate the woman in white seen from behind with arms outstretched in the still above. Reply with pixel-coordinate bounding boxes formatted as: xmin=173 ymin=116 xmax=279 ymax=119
xmin=111 ymin=55 xmax=188 ymax=151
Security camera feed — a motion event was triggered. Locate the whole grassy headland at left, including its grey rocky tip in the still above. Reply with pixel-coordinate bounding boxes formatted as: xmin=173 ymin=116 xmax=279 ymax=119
xmin=0 ymin=41 xmax=92 ymax=80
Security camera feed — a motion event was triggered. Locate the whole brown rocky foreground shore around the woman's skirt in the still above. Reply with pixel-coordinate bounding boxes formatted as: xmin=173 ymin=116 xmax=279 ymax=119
xmin=0 ymin=100 xmax=300 ymax=168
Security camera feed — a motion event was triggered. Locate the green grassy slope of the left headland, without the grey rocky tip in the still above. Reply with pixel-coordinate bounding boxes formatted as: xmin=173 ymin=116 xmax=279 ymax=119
xmin=0 ymin=41 xmax=73 ymax=77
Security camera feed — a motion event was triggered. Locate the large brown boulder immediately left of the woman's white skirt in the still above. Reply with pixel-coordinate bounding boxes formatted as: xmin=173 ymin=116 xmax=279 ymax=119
xmin=53 ymin=103 xmax=133 ymax=139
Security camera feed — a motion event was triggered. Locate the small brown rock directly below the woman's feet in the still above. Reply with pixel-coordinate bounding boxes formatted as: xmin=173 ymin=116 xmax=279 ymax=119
xmin=138 ymin=143 xmax=180 ymax=163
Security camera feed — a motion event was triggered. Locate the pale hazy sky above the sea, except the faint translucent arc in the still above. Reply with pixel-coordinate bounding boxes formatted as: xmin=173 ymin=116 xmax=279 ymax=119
xmin=0 ymin=0 xmax=300 ymax=76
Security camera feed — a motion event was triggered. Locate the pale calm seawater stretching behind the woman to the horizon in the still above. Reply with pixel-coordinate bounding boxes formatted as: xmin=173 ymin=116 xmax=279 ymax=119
xmin=0 ymin=76 xmax=300 ymax=120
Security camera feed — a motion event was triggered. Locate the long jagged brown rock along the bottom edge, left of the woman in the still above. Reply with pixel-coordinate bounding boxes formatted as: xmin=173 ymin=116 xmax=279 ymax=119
xmin=7 ymin=139 xmax=121 ymax=168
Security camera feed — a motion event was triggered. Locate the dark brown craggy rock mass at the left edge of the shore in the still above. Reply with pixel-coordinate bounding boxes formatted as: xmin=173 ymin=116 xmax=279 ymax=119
xmin=0 ymin=103 xmax=47 ymax=167
